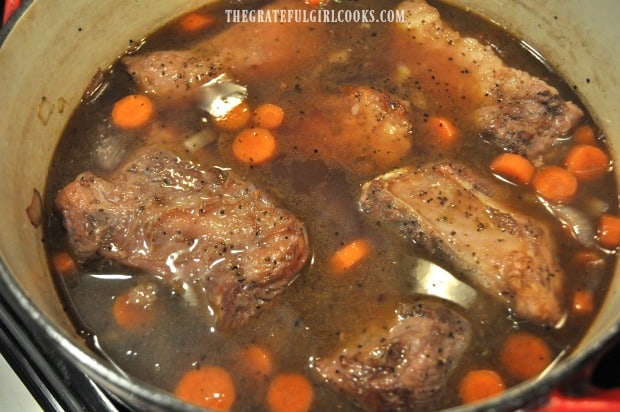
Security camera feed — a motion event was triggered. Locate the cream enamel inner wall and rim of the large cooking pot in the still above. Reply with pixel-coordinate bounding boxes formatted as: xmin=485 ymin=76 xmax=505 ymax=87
xmin=0 ymin=0 xmax=620 ymax=411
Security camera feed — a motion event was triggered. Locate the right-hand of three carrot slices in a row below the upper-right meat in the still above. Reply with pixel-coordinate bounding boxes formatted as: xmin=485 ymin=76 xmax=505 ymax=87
xmin=564 ymin=144 xmax=610 ymax=181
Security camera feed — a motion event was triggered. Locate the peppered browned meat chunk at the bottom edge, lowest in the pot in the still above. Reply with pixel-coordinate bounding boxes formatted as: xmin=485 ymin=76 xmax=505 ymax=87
xmin=315 ymin=300 xmax=471 ymax=411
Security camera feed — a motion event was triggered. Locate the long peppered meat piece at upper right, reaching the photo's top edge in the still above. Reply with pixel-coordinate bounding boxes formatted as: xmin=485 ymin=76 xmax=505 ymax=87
xmin=393 ymin=0 xmax=583 ymax=159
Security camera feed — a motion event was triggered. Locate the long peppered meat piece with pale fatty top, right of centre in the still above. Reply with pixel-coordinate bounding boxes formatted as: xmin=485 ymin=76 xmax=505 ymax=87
xmin=360 ymin=163 xmax=564 ymax=324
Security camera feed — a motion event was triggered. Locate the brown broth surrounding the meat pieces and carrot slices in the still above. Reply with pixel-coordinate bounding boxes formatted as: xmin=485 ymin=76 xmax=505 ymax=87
xmin=45 ymin=1 xmax=617 ymax=411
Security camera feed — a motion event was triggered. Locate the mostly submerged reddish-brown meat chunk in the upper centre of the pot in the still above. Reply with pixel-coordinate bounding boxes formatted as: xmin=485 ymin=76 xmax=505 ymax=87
xmin=282 ymin=87 xmax=413 ymax=176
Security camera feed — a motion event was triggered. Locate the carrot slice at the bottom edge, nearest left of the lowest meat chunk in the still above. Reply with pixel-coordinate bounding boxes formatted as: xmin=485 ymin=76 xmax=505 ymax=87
xmin=267 ymin=373 xmax=314 ymax=412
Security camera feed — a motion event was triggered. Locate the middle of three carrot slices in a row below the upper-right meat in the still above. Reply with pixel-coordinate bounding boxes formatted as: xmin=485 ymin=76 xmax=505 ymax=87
xmin=532 ymin=166 xmax=578 ymax=203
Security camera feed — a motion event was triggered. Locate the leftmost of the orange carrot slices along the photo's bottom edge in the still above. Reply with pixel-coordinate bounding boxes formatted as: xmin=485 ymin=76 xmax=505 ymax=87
xmin=174 ymin=366 xmax=236 ymax=411
